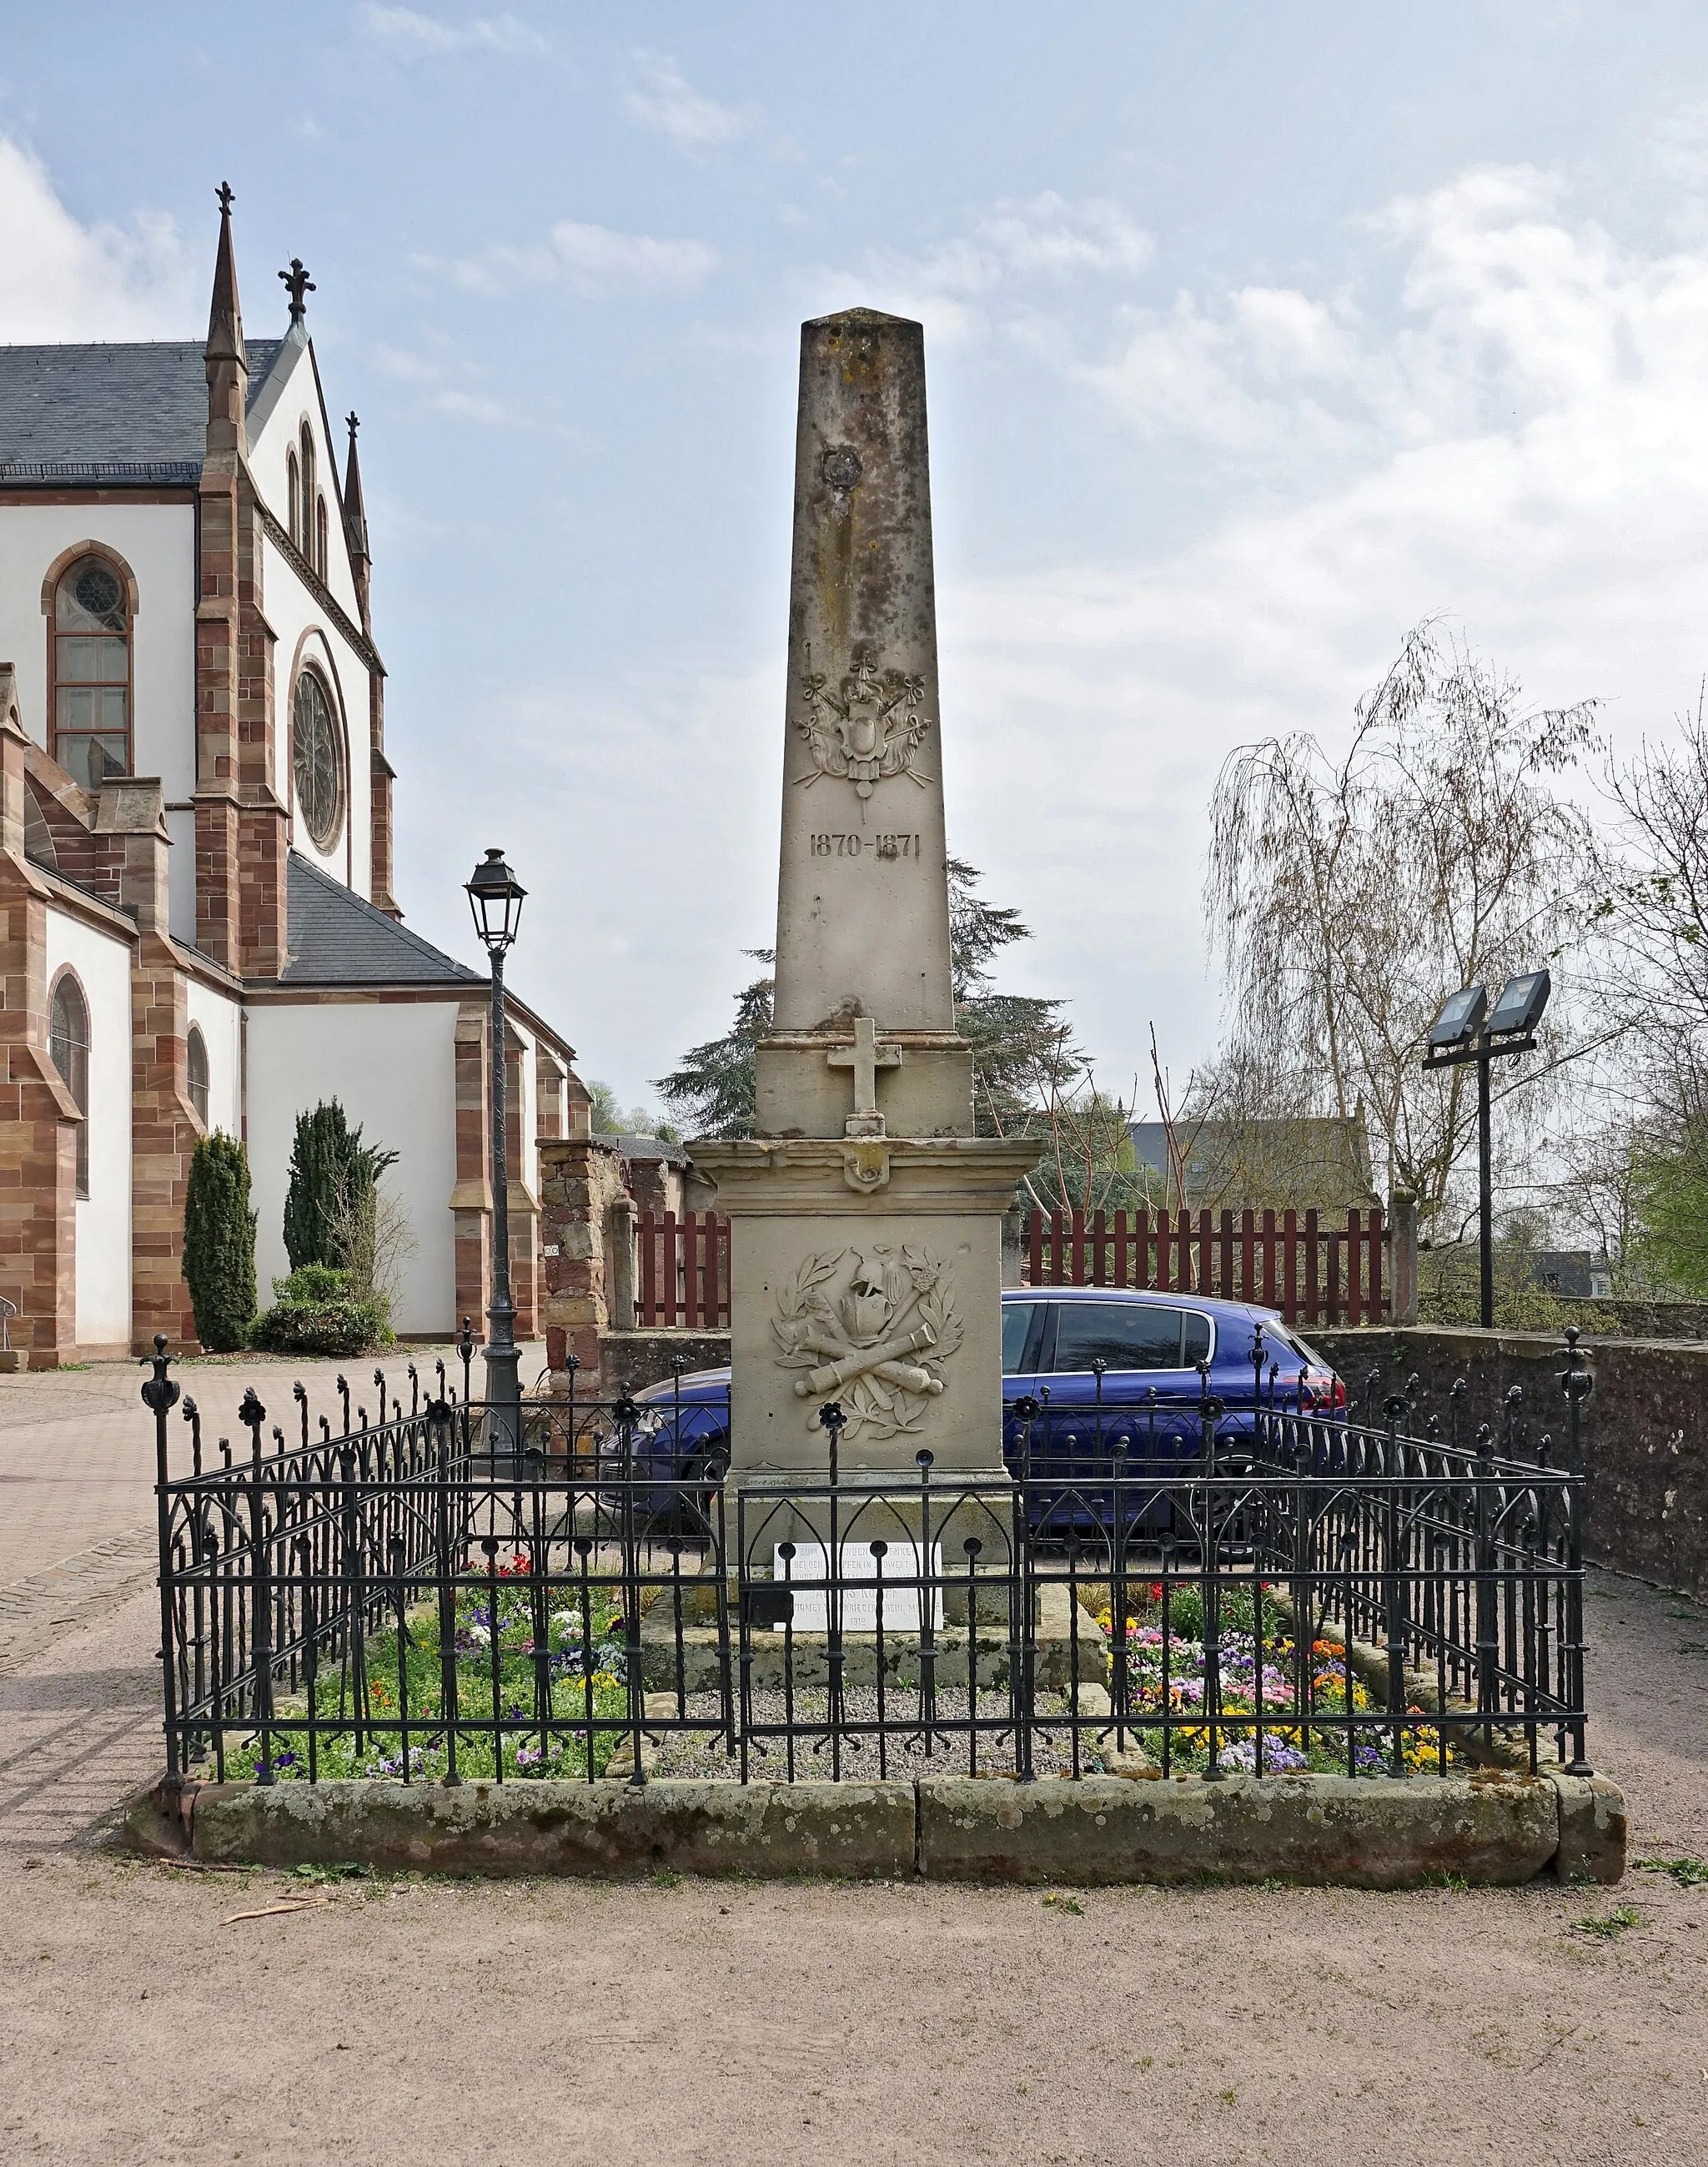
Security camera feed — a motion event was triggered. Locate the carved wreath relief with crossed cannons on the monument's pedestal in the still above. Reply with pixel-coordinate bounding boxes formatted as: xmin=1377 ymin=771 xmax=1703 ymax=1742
xmin=771 ymin=1244 xmax=967 ymax=1441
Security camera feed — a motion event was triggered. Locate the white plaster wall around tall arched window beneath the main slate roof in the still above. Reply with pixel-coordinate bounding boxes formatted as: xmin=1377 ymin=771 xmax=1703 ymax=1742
xmin=0 ymin=505 xmax=196 ymax=800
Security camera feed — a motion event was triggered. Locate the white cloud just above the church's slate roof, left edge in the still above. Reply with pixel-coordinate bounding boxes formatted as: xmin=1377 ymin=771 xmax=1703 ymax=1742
xmin=0 ymin=137 xmax=193 ymax=344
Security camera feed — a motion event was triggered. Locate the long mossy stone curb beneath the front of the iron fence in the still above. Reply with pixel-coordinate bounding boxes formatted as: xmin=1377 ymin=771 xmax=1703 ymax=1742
xmin=123 ymin=1771 xmax=1625 ymax=1889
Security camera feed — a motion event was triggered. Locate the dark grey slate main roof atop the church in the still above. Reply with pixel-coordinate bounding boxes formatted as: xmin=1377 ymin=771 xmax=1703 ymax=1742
xmin=0 ymin=338 xmax=282 ymax=485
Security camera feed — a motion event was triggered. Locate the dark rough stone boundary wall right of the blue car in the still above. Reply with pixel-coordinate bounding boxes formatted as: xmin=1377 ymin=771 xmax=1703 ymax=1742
xmin=1309 ymin=1326 xmax=1708 ymax=1597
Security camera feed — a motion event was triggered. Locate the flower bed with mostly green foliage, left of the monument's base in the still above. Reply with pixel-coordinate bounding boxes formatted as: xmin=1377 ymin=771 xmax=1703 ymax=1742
xmin=225 ymin=1558 xmax=629 ymax=1783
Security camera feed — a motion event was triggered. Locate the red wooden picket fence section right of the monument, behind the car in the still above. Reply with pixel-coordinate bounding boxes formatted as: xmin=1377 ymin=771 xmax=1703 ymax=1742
xmin=1025 ymin=1209 xmax=1394 ymax=1324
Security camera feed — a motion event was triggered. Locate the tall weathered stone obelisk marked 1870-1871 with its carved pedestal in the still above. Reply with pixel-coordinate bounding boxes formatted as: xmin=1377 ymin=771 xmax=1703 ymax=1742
xmin=689 ymin=308 xmax=1038 ymax=1482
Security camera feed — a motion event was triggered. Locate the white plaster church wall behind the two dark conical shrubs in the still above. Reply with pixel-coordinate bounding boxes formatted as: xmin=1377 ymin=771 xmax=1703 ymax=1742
xmin=247 ymin=1001 xmax=457 ymax=1333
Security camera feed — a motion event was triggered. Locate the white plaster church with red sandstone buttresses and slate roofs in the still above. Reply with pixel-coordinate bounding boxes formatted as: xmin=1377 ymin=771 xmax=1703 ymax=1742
xmin=0 ymin=189 xmax=587 ymax=1367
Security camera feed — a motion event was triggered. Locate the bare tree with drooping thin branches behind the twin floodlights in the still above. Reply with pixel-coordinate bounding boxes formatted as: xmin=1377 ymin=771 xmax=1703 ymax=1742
xmin=1205 ymin=622 xmax=1595 ymax=1222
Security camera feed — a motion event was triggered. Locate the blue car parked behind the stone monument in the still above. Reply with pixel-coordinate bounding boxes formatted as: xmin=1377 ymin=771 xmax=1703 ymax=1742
xmin=633 ymin=1287 xmax=1346 ymax=1508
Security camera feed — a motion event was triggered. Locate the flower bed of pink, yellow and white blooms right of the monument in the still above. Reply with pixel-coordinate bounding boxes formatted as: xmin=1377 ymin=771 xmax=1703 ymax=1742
xmin=1097 ymin=1582 xmax=1454 ymax=1775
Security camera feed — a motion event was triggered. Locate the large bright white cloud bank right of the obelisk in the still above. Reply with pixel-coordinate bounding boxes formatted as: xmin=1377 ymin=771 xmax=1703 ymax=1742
xmin=938 ymin=169 xmax=1708 ymax=1073
